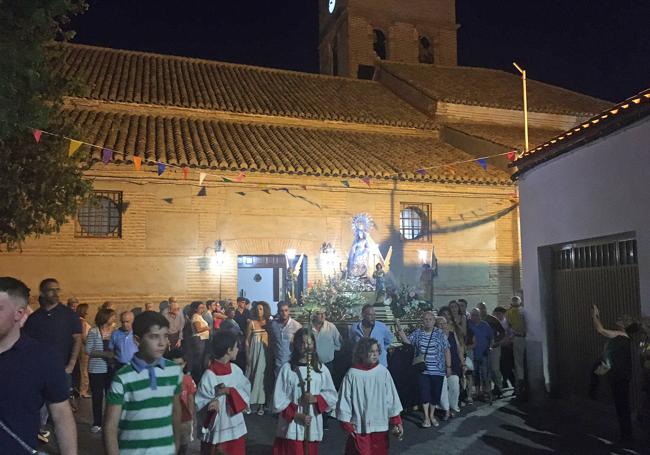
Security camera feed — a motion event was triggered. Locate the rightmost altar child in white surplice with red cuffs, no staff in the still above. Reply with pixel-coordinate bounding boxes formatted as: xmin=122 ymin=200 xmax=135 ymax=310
xmin=336 ymin=338 xmax=404 ymax=455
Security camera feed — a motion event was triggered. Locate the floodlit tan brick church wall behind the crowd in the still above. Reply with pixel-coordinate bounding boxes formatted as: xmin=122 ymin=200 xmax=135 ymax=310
xmin=0 ymin=168 xmax=520 ymax=318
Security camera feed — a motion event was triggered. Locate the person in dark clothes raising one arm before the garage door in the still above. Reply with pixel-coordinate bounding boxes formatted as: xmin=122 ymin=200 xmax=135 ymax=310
xmin=592 ymin=305 xmax=638 ymax=440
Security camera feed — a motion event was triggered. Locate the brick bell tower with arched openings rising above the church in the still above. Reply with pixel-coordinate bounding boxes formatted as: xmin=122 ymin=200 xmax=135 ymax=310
xmin=319 ymin=0 xmax=458 ymax=79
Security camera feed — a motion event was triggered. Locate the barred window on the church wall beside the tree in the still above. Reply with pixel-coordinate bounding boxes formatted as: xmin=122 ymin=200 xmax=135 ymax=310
xmin=75 ymin=191 xmax=122 ymax=238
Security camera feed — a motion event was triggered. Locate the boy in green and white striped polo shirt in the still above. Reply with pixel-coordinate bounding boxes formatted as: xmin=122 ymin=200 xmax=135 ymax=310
xmin=104 ymin=311 xmax=183 ymax=455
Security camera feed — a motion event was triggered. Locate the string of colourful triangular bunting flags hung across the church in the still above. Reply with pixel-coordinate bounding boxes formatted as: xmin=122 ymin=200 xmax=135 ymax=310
xmin=32 ymin=129 xmax=517 ymax=201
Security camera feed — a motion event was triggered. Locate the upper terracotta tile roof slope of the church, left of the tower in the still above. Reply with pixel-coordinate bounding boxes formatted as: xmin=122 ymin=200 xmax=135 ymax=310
xmin=57 ymin=44 xmax=432 ymax=128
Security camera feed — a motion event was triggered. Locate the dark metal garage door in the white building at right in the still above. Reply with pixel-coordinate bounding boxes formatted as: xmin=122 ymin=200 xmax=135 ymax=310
xmin=552 ymin=237 xmax=641 ymax=403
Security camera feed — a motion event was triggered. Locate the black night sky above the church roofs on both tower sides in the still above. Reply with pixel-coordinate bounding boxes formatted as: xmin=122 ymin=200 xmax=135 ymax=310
xmin=71 ymin=0 xmax=650 ymax=101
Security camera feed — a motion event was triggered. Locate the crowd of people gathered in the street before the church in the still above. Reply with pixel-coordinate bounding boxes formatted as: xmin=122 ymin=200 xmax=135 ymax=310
xmin=0 ymin=277 xmax=644 ymax=455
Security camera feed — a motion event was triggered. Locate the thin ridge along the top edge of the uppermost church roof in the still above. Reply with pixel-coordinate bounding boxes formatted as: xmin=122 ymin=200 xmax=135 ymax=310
xmin=58 ymin=42 xmax=378 ymax=84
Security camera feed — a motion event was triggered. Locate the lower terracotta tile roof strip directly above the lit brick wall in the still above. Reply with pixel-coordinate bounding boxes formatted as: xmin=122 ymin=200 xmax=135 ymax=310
xmin=64 ymin=107 xmax=510 ymax=184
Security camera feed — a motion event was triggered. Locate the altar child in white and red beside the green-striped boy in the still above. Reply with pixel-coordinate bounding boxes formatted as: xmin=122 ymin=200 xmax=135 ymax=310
xmin=195 ymin=331 xmax=251 ymax=455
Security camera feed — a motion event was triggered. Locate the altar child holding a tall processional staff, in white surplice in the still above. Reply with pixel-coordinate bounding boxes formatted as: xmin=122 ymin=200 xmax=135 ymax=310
xmin=273 ymin=329 xmax=337 ymax=455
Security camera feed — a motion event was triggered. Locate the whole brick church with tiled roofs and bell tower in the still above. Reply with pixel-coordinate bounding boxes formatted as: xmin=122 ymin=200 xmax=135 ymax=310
xmin=0 ymin=0 xmax=607 ymax=314
